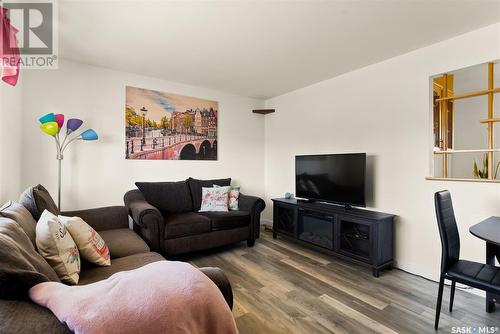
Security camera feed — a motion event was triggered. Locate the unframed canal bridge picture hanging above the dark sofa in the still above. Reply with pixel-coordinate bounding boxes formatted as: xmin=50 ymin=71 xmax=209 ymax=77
xmin=125 ymin=86 xmax=219 ymax=160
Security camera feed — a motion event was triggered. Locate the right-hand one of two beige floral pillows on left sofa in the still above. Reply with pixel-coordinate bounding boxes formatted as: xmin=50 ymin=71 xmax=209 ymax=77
xmin=59 ymin=216 xmax=111 ymax=266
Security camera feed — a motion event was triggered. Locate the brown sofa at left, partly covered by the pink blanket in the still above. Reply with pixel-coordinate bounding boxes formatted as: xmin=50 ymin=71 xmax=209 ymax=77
xmin=0 ymin=187 xmax=233 ymax=333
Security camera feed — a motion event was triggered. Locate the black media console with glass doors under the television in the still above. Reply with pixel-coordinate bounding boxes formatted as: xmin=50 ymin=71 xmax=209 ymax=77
xmin=273 ymin=198 xmax=395 ymax=277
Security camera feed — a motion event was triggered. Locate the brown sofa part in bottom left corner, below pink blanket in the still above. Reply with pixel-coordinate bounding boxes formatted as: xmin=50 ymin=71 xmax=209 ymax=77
xmin=0 ymin=300 xmax=72 ymax=334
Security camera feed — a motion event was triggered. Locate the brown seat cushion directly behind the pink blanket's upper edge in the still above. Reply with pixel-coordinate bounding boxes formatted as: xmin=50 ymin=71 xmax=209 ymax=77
xmin=78 ymin=252 xmax=165 ymax=285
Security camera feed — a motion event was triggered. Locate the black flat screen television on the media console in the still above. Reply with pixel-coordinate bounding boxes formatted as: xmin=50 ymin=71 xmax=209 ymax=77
xmin=295 ymin=153 xmax=366 ymax=207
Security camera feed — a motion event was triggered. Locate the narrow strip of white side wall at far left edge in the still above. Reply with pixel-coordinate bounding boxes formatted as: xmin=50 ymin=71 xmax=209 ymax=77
xmin=0 ymin=81 xmax=24 ymax=205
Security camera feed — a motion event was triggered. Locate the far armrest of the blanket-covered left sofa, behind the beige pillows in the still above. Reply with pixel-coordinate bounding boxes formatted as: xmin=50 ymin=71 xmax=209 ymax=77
xmin=61 ymin=206 xmax=129 ymax=231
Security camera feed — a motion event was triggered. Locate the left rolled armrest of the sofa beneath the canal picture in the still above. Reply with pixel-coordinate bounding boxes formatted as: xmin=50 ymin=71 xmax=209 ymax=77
xmin=123 ymin=189 xmax=165 ymax=252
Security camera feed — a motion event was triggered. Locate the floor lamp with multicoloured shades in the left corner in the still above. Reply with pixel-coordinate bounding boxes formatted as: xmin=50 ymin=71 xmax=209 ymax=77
xmin=39 ymin=113 xmax=98 ymax=210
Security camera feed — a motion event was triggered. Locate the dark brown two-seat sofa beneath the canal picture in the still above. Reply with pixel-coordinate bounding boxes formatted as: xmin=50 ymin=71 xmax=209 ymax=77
xmin=124 ymin=178 xmax=265 ymax=255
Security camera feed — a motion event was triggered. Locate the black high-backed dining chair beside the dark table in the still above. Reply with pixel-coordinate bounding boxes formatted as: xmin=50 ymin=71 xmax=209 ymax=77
xmin=434 ymin=190 xmax=500 ymax=329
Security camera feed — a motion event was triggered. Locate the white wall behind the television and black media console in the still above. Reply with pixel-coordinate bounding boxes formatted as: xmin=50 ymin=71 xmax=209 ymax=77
xmin=264 ymin=24 xmax=500 ymax=279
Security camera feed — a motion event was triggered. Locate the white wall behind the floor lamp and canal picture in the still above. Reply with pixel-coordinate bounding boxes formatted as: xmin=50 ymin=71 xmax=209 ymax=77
xmin=22 ymin=61 xmax=264 ymax=209
